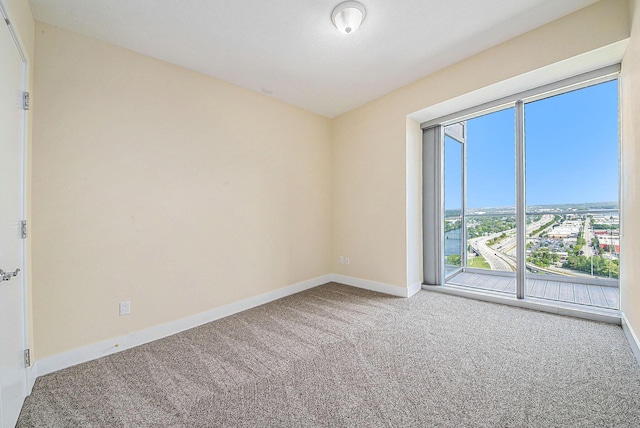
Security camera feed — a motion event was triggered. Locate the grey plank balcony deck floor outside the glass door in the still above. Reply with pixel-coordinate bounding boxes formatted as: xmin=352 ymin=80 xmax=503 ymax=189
xmin=446 ymin=272 xmax=620 ymax=310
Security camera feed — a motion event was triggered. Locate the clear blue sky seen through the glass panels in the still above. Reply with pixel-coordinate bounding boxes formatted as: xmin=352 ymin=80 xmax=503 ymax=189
xmin=445 ymin=81 xmax=618 ymax=209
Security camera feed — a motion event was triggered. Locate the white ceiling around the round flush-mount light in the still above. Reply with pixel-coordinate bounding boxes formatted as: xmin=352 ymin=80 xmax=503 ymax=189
xmin=29 ymin=0 xmax=597 ymax=118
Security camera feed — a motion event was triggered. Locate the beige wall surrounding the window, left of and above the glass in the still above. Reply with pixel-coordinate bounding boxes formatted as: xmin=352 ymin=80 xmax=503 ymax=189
xmin=332 ymin=0 xmax=629 ymax=287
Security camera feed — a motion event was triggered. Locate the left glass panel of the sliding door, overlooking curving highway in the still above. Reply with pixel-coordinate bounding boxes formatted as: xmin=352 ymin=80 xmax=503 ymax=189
xmin=445 ymin=108 xmax=516 ymax=294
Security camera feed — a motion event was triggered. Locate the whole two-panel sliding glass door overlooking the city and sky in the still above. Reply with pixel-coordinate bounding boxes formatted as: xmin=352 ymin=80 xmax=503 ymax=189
xmin=425 ymin=72 xmax=620 ymax=309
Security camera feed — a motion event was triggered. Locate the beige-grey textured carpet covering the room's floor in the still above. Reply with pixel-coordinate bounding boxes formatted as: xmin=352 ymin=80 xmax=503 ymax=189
xmin=18 ymin=284 xmax=640 ymax=427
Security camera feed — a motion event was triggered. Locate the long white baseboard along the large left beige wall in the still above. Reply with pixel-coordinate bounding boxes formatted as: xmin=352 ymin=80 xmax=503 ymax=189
xmin=37 ymin=275 xmax=332 ymax=380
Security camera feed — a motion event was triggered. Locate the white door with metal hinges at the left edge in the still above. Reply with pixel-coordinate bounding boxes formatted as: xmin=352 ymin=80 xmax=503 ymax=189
xmin=0 ymin=9 xmax=27 ymax=428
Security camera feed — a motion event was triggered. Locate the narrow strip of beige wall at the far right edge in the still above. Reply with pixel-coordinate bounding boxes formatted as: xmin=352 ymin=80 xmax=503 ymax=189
xmin=620 ymin=0 xmax=640 ymax=334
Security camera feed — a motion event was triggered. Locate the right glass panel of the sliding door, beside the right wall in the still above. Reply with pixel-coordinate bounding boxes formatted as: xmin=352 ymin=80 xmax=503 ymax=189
xmin=525 ymin=81 xmax=620 ymax=309
